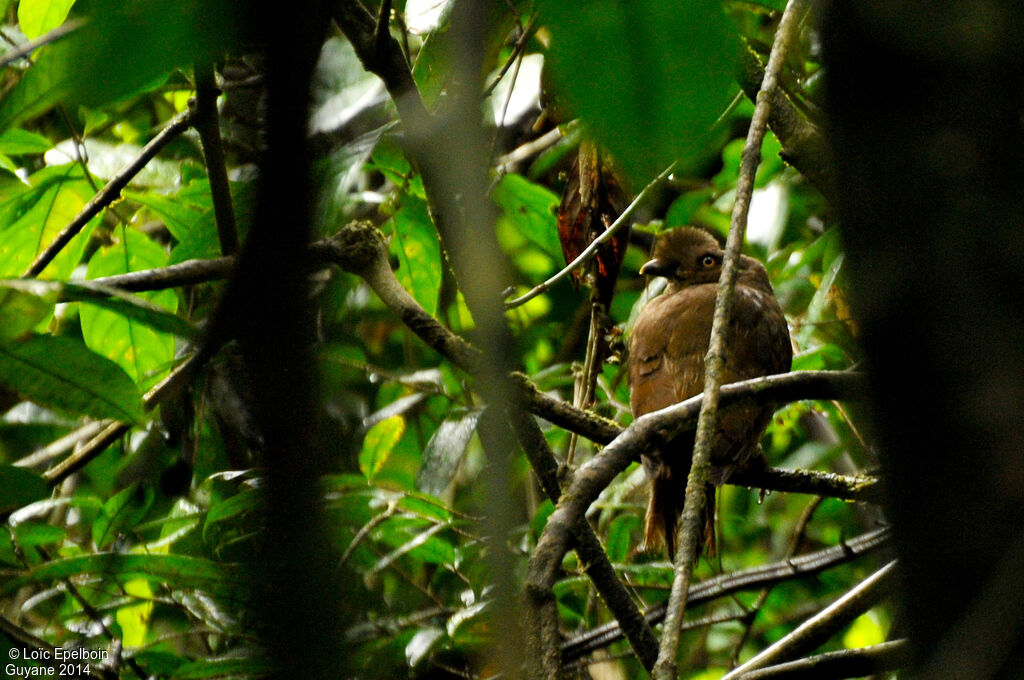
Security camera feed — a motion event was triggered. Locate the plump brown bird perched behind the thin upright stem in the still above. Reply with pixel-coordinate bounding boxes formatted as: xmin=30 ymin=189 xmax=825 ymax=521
xmin=629 ymin=227 xmax=793 ymax=558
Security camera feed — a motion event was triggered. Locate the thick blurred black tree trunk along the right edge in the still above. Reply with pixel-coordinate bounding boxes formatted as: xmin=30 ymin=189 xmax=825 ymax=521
xmin=822 ymin=0 xmax=1024 ymax=678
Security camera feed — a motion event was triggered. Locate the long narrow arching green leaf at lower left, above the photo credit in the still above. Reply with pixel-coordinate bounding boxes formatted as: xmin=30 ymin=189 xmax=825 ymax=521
xmin=0 ymin=553 xmax=251 ymax=595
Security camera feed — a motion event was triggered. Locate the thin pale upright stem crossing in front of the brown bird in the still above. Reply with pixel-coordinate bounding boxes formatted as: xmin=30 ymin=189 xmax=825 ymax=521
xmin=652 ymin=0 xmax=810 ymax=680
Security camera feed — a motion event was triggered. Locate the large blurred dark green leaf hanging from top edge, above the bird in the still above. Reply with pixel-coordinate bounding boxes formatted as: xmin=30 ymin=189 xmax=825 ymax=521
xmin=539 ymin=0 xmax=737 ymax=186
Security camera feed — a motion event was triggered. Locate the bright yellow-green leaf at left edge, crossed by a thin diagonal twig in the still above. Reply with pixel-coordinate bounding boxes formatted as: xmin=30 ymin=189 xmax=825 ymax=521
xmin=0 ymin=166 xmax=99 ymax=279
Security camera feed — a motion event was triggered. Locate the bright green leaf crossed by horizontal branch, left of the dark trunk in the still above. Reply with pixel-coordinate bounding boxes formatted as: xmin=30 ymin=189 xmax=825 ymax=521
xmin=81 ymin=229 xmax=178 ymax=389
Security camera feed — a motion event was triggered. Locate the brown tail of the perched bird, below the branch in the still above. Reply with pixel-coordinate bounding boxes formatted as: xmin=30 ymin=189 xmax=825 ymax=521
xmin=643 ymin=465 xmax=718 ymax=561
